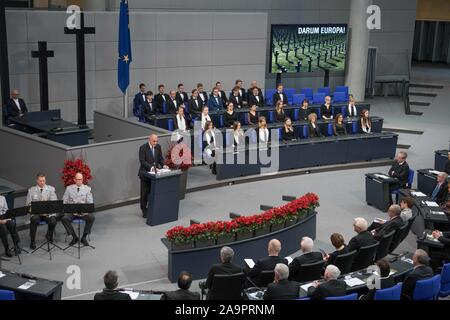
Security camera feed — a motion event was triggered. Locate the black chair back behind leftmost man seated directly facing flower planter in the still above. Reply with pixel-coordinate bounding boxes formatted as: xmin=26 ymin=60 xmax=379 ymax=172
xmin=206 ymin=272 xmax=245 ymax=300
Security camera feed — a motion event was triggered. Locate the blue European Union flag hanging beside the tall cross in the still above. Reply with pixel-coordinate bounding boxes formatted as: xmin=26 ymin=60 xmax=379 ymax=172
xmin=117 ymin=0 xmax=131 ymax=94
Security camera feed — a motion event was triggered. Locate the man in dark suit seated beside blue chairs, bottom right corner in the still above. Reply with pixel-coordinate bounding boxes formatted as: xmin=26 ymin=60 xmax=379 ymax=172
xmin=402 ymin=249 xmax=434 ymax=300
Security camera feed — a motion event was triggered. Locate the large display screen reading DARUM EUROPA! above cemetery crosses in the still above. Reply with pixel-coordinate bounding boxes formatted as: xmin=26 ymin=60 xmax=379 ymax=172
xmin=270 ymin=24 xmax=347 ymax=73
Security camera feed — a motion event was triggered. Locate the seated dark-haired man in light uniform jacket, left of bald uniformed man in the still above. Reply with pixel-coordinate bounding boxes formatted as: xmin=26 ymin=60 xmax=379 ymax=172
xmin=26 ymin=173 xmax=58 ymax=250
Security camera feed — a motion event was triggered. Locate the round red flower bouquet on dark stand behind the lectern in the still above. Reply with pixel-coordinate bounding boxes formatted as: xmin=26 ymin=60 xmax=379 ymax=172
xmin=165 ymin=142 xmax=192 ymax=200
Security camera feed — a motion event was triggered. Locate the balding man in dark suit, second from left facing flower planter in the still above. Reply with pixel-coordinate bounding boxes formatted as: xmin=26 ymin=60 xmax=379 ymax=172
xmin=245 ymin=239 xmax=288 ymax=287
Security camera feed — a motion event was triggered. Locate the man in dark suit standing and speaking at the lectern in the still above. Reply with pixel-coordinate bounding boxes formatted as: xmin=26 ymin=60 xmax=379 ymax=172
xmin=138 ymin=134 xmax=167 ymax=218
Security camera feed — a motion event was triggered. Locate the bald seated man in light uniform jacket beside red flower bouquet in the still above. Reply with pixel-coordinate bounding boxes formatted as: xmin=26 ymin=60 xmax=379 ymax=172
xmin=61 ymin=172 xmax=95 ymax=246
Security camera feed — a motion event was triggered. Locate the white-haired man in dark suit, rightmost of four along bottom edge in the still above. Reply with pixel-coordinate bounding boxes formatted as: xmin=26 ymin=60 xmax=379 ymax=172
xmin=308 ymin=264 xmax=347 ymax=300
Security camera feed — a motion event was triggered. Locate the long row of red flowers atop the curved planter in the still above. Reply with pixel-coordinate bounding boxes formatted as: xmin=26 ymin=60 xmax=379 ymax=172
xmin=166 ymin=193 xmax=319 ymax=243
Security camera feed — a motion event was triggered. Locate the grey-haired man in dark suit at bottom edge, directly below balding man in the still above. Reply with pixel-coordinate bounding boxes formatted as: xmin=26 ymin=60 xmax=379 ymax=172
xmin=263 ymin=263 xmax=300 ymax=300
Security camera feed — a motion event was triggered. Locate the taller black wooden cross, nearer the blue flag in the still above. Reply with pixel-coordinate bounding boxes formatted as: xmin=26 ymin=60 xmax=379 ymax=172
xmin=64 ymin=12 xmax=95 ymax=127
